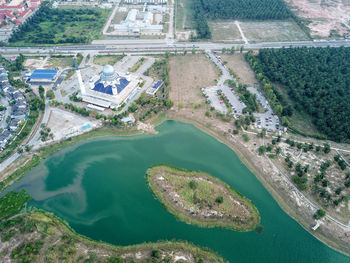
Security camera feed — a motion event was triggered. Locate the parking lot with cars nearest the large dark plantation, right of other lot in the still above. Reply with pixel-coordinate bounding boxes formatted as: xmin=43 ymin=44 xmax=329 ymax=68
xmin=247 ymin=87 xmax=280 ymax=131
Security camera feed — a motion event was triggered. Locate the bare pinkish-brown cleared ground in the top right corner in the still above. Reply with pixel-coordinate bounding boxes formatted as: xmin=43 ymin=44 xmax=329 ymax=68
xmin=286 ymin=0 xmax=350 ymax=38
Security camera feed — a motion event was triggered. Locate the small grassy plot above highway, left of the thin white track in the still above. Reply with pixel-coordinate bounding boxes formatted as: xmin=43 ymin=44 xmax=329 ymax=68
xmin=209 ymin=21 xmax=243 ymax=43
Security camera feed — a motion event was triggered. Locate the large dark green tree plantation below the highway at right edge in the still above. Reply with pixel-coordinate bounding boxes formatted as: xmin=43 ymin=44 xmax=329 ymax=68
xmin=247 ymin=47 xmax=350 ymax=141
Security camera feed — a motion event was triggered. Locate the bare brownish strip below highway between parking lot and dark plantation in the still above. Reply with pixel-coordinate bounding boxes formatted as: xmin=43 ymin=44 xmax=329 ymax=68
xmin=221 ymin=53 xmax=259 ymax=86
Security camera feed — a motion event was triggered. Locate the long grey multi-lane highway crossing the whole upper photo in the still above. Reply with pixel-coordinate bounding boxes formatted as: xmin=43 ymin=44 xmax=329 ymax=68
xmin=0 ymin=39 xmax=350 ymax=55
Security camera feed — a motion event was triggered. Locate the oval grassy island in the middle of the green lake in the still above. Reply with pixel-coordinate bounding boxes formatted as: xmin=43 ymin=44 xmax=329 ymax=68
xmin=147 ymin=165 xmax=260 ymax=231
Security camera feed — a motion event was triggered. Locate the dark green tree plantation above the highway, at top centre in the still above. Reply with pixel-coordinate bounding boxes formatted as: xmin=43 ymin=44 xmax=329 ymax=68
xmin=192 ymin=0 xmax=295 ymax=38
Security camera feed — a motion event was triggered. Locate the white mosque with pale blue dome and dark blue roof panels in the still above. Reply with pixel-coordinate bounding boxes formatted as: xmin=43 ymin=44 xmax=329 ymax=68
xmin=78 ymin=65 xmax=140 ymax=108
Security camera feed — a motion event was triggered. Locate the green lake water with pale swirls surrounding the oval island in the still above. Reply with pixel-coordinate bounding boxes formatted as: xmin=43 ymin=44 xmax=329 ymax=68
xmin=11 ymin=121 xmax=350 ymax=263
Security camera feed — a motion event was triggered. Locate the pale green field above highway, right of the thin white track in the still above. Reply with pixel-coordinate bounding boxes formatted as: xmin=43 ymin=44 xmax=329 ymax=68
xmin=240 ymin=20 xmax=308 ymax=42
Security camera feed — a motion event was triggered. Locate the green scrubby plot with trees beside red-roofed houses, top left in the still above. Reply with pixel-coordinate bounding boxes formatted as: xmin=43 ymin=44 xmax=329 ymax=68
xmin=9 ymin=2 xmax=108 ymax=44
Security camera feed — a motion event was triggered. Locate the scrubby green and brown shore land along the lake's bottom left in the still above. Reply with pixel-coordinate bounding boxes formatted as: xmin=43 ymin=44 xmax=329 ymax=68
xmin=0 ymin=192 xmax=226 ymax=263
